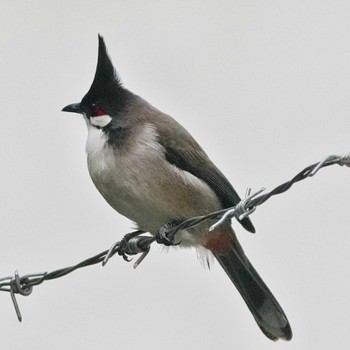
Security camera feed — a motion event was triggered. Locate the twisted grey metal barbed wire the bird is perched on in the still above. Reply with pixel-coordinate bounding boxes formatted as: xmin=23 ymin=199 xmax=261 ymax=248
xmin=0 ymin=153 xmax=350 ymax=322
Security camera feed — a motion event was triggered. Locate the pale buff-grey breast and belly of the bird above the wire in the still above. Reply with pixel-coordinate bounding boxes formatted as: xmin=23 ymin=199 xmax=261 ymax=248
xmin=88 ymin=126 xmax=221 ymax=243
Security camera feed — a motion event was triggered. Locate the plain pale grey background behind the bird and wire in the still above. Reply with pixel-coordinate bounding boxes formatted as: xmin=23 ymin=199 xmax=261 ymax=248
xmin=0 ymin=0 xmax=350 ymax=350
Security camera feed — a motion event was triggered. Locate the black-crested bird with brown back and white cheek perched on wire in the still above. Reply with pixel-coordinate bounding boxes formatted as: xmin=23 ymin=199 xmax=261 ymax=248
xmin=62 ymin=34 xmax=292 ymax=340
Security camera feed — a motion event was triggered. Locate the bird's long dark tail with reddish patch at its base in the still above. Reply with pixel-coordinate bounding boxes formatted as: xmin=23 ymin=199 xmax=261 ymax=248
xmin=204 ymin=226 xmax=292 ymax=340
